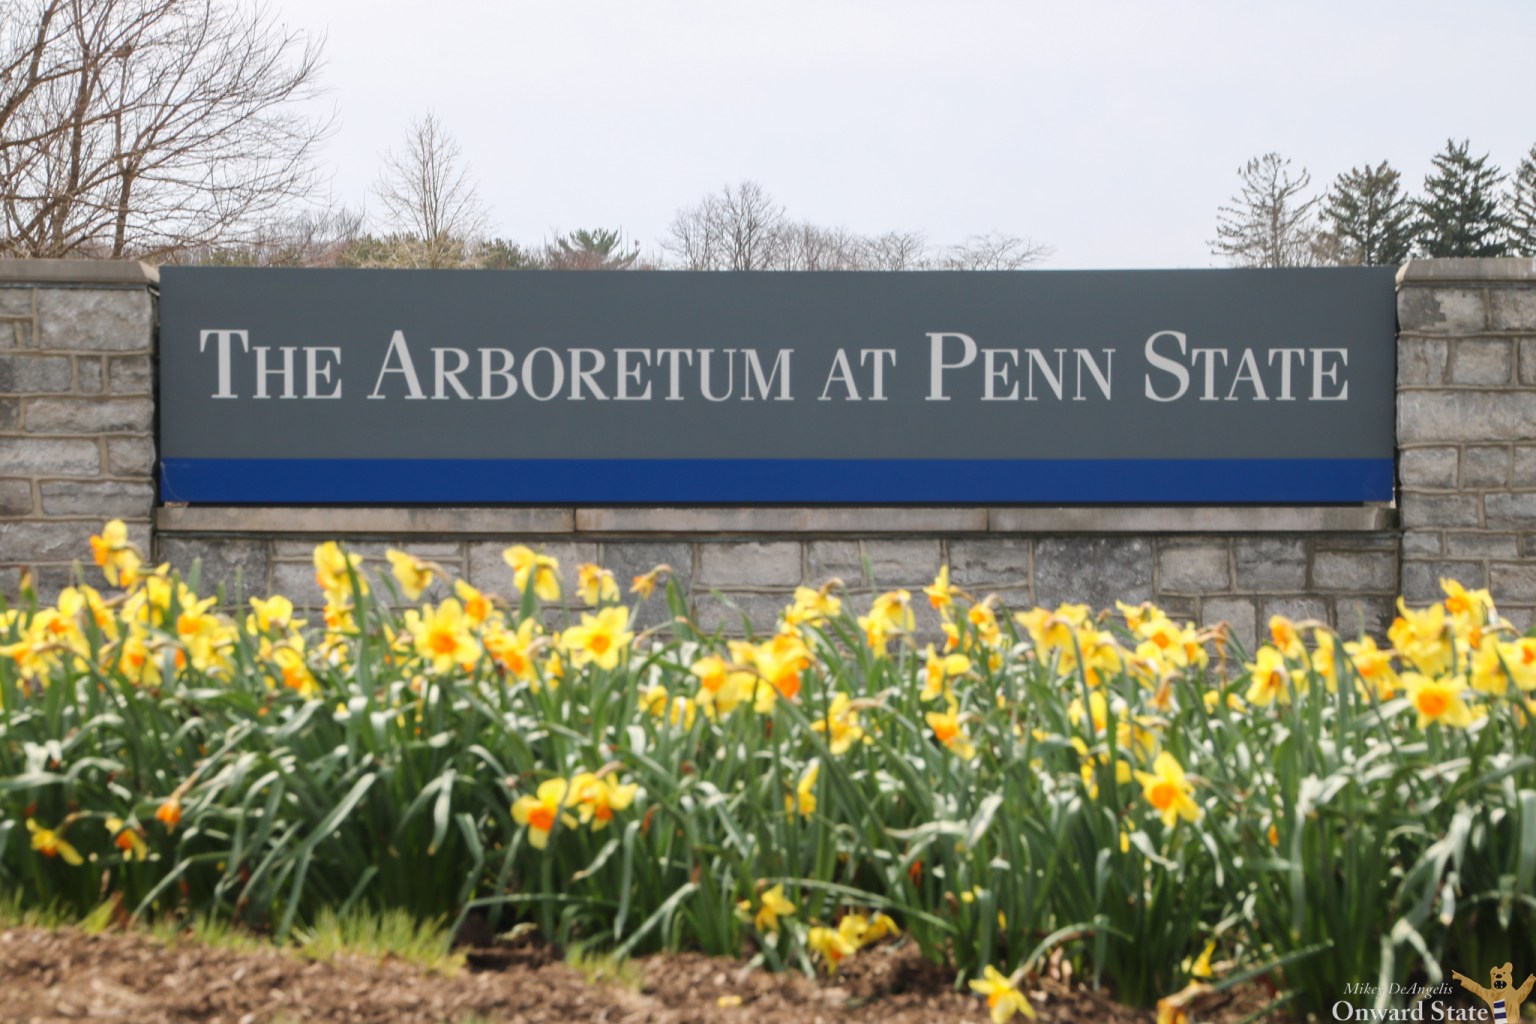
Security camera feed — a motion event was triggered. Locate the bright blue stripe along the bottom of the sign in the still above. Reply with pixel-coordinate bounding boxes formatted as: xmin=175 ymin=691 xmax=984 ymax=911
xmin=160 ymin=459 xmax=1393 ymax=505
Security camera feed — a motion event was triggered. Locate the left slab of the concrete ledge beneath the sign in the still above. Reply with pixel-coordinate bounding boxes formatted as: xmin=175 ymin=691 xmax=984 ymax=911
xmin=155 ymin=507 xmax=576 ymax=539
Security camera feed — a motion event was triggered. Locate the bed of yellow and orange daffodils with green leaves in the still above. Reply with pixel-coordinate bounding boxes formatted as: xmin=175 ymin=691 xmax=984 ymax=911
xmin=0 ymin=524 xmax=1536 ymax=1019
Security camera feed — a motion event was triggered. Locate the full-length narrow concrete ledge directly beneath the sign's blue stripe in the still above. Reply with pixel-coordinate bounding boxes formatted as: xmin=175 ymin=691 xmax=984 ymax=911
xmin=155 ymin=507 xmax=1396 ymax=537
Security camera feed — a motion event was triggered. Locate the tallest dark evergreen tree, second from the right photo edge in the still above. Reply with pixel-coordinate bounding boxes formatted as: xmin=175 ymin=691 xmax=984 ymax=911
xmin=1415 ymin=140 xmax=1510 ymax=256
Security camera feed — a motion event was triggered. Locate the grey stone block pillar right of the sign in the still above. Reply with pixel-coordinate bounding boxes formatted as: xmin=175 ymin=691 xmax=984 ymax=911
xmin=1398 ymin=259 xmax=1536 ymax=629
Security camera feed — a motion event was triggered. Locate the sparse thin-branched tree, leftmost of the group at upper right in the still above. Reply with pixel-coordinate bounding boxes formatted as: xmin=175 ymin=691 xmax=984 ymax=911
xmin=1210 ymin=154 xmax=1326 ymax=267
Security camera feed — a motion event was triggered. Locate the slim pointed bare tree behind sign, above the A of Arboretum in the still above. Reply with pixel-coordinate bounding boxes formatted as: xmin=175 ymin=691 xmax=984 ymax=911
xmin=373 ymin=114 xmax=490 ymax=267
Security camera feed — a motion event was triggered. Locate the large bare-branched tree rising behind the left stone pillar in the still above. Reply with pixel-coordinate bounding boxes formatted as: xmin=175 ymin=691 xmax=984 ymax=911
xmin=0 ymin=0 xmax=329 ymax=259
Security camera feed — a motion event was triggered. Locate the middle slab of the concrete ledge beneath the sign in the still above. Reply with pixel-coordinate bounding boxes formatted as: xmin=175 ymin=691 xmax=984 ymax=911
xmin=576 ymin=508 xmax=986 ymax=534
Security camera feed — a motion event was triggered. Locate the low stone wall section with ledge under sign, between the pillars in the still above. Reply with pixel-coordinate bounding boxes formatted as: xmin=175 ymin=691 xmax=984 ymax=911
xmin=157 ymin=508 xmax=1398 ymax=643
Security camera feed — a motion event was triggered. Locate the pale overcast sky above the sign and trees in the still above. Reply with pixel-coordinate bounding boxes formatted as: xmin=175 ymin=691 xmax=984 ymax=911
xmin=272 ymin=0 xmax=1536 ymax=269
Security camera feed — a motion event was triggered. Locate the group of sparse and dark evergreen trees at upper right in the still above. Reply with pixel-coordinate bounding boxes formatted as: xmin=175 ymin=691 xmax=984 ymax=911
xmin=1210 ymin=140 xmax=1536 ymax=267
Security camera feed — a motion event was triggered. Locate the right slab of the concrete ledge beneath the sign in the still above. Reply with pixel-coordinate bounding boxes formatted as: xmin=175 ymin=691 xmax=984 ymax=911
xmin=988 ymin=507 xmax=1396 ymax=533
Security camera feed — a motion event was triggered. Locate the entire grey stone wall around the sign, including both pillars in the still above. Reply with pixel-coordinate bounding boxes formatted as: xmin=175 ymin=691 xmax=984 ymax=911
xmin=0 ymin=259 xmax=1536 ymax=640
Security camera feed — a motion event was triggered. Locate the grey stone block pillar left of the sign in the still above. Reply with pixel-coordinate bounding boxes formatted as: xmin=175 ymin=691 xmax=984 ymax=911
xmin=0 ymin=259 xmax=160 ymax=600
